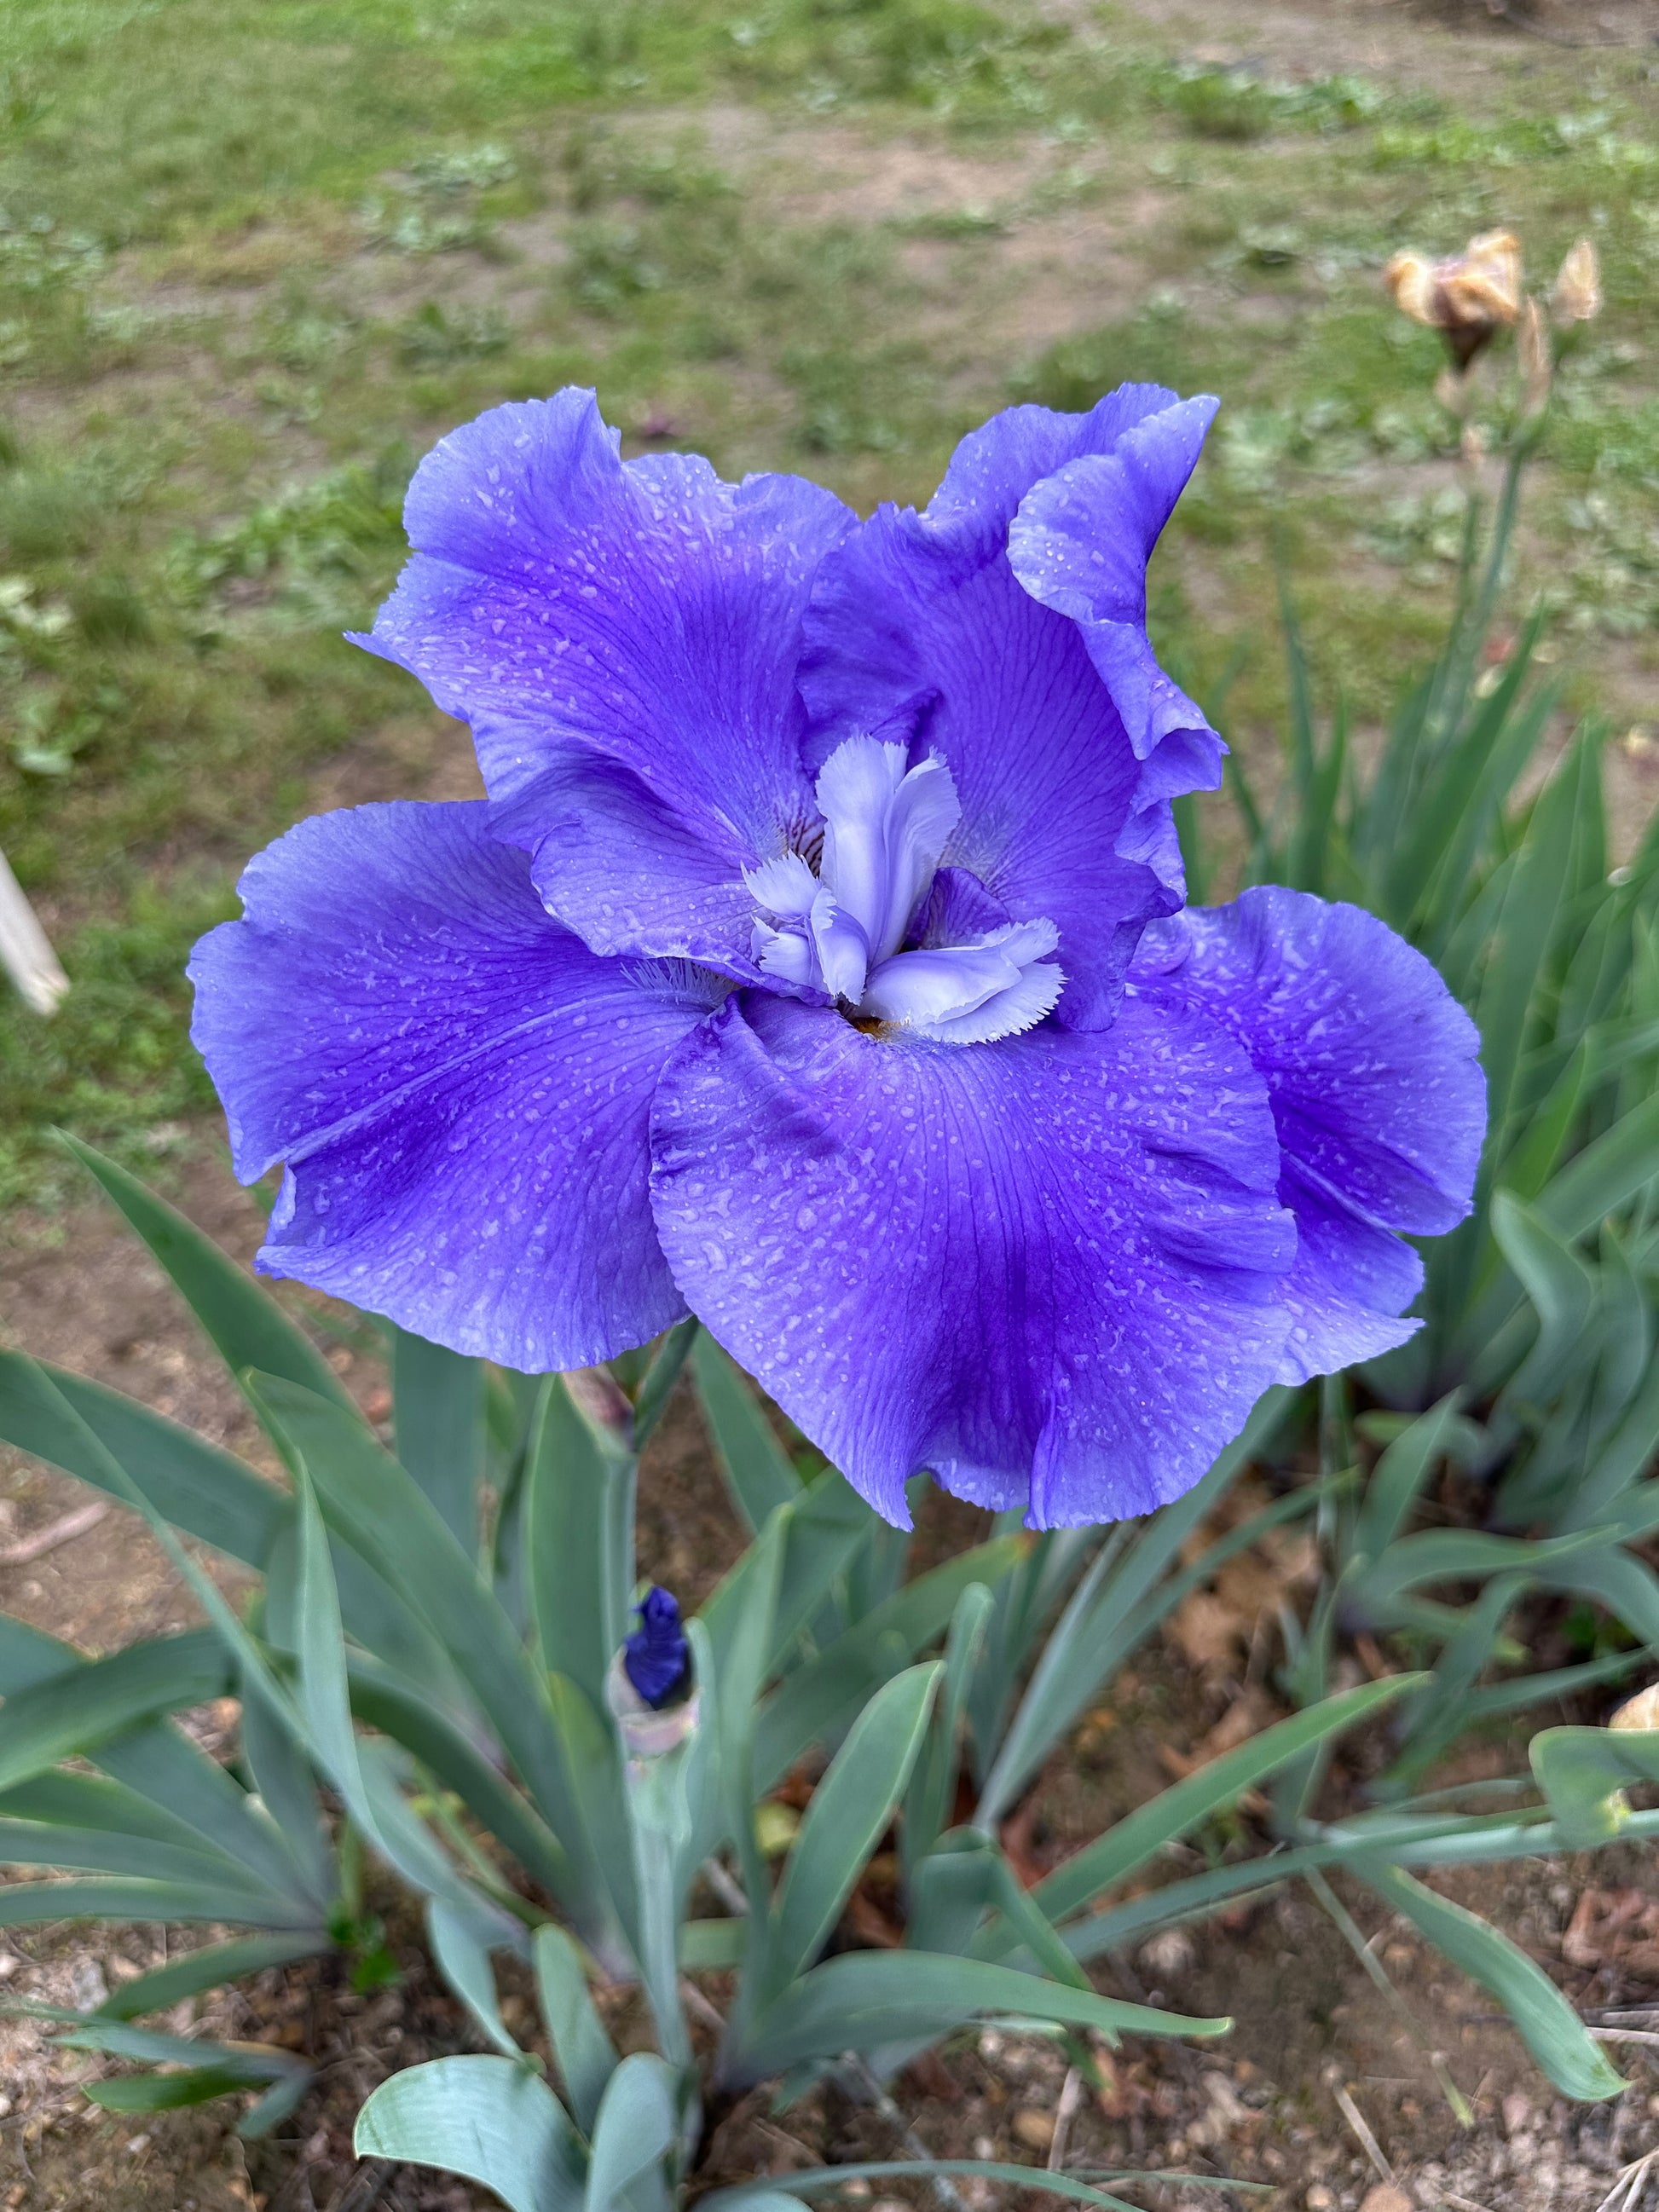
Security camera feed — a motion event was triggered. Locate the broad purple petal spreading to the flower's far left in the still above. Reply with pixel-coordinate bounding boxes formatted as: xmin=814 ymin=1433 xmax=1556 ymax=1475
xmin=190 ymin=803 xmax=714 ymax=1373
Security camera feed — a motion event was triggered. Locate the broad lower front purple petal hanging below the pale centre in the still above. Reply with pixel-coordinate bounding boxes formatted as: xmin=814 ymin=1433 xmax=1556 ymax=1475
xmin=652 ymin=993 xmax=1294 ymax=1527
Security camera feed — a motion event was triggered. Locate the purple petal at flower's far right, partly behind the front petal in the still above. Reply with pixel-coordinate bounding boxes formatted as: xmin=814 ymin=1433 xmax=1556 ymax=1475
xmin=1130 ymin=887 xmax=1487 ymax=1383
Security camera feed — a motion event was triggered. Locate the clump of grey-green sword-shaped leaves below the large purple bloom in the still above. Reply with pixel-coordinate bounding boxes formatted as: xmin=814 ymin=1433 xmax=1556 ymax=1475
xmin=0 ymin=1148 xmax=1659 ymax=2176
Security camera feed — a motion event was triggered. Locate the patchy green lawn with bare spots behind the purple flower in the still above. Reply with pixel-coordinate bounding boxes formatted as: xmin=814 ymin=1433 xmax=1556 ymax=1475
xmin=0 ymin=0 xmax=1659 ymax=1204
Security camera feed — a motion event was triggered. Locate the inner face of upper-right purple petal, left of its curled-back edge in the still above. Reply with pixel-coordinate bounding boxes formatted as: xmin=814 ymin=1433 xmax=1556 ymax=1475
xmin=801 ymin=385 xmax=1214 ymax=1029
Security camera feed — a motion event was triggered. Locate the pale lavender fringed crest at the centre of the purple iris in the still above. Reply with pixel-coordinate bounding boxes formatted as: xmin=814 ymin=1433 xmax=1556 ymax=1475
xmin=743 ymin=736 xmax=1066 ymax=1044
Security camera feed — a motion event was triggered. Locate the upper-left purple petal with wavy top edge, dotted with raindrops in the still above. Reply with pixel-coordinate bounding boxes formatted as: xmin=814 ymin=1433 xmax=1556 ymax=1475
xmin=358 ymin=390 xmax=854 ymax=863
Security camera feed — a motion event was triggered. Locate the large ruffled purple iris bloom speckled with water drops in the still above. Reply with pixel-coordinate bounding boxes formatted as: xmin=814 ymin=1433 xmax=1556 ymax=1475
xmin=193 ymin=385 xmax=1484 ymax=1527
